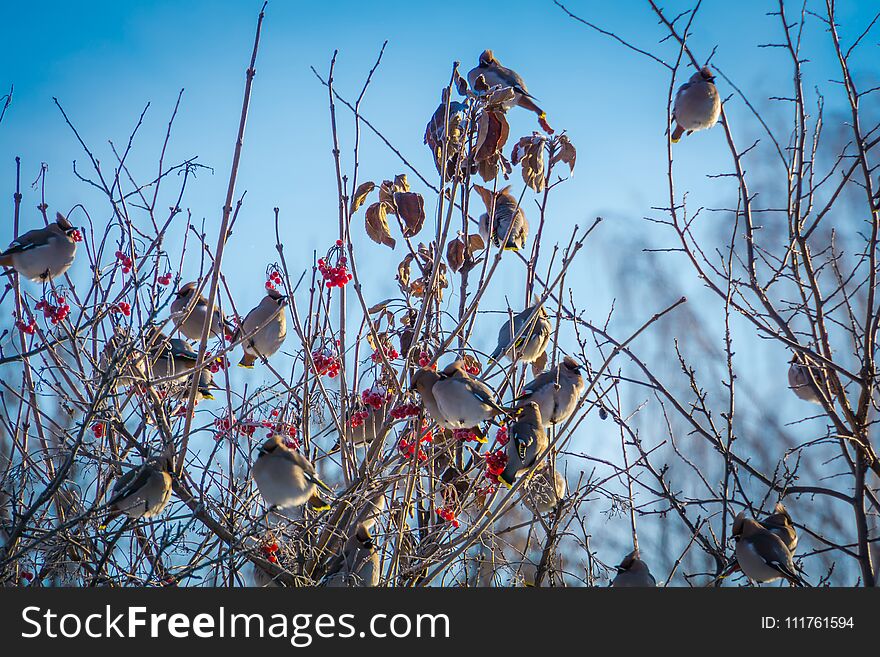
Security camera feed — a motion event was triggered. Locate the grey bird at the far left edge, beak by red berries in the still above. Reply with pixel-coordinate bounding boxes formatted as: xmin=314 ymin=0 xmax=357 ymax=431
xmin=0 ymin=212 xmax=82 ymax=282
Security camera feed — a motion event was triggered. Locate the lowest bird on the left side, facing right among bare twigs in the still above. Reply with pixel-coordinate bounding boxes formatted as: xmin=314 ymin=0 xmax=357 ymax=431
xmin=104 ymin=454 xmax=171 ymax=524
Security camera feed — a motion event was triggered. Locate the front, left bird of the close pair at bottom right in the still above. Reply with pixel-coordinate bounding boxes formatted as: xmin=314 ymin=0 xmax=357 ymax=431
xmin=733 ymin=511 xmax=806 ymax=586
